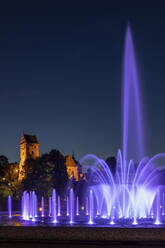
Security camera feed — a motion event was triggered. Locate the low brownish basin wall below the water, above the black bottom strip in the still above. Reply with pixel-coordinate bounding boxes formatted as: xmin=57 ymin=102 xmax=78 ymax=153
xmin=0 ymin=226 xmax=165 ymax=242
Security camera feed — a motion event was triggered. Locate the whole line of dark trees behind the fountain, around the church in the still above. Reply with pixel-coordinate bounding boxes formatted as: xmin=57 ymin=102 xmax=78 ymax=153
xmin=0 ymin=150 xmax=116 ymax=207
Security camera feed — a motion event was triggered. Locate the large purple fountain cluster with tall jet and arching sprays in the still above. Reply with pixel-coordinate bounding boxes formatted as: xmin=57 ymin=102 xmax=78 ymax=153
xmin=80 ymin=26 xmax=165 ymax=225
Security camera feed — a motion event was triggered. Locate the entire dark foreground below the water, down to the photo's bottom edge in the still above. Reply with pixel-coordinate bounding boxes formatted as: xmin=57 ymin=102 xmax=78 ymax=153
xmin=0 ymin=226 xmax=165 ymax=248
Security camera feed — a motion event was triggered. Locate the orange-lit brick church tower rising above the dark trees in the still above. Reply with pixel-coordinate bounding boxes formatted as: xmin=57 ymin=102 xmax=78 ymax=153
xmin=18 ymin=133 xmax=39 ymax=181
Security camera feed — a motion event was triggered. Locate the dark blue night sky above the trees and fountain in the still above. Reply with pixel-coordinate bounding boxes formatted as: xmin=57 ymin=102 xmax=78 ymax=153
xmin=0 ymin=0 xmax=165 ymax=161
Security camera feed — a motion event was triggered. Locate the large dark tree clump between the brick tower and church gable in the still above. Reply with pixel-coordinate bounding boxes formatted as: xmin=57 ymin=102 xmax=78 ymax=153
xmin=22 ymin=150 xmax=68 ymax=200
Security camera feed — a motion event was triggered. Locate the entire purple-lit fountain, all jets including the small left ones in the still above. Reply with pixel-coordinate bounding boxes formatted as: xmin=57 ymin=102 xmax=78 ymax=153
xmin=4 ymin=26 xmax=165 ymax=226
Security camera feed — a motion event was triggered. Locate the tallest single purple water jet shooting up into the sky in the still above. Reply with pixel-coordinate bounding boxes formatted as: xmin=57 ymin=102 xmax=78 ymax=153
xmin=123 ymin=26 xmax=144 ymax=162
